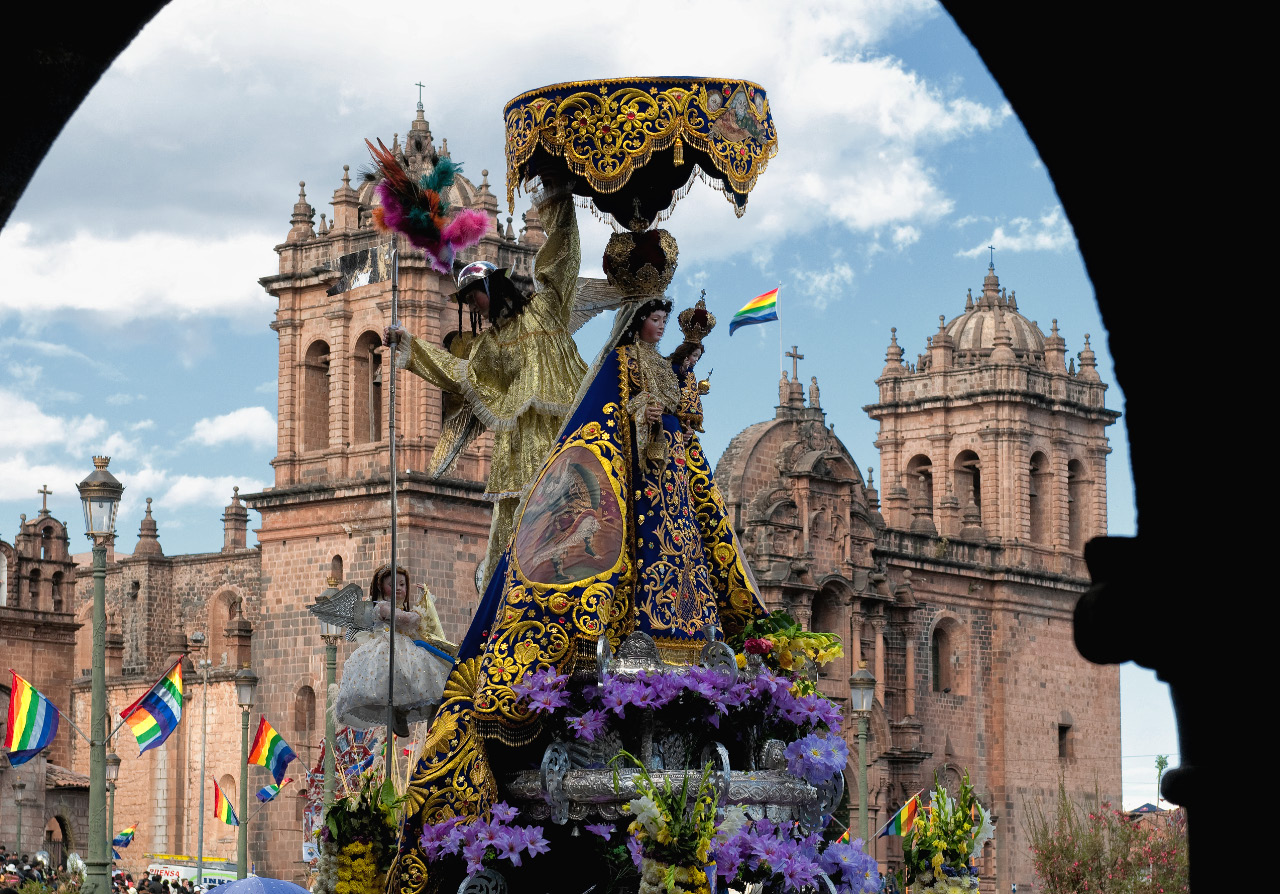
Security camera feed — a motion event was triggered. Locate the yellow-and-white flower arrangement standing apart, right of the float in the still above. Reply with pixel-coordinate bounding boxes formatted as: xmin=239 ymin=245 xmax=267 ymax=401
xmin=902 ymin=772 xmax=992 ymax=894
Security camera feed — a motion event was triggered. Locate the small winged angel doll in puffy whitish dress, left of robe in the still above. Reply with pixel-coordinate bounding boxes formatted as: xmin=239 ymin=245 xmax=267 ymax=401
xmin=334 ymin=565 xmax=457 ymax=736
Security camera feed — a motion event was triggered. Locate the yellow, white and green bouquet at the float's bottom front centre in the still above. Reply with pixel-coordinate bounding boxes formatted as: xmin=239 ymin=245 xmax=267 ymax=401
xmin=611 ymin=751 xmax=716 ymax=894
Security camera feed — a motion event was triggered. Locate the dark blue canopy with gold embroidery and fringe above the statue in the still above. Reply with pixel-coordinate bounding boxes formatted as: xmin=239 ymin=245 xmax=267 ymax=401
xmin=504 ymin=78 xmax=778 ymax=221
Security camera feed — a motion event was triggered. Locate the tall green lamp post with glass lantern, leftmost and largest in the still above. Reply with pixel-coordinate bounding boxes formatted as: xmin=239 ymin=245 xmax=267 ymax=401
xmin=76 ymin=456 xmax=124 ymax=894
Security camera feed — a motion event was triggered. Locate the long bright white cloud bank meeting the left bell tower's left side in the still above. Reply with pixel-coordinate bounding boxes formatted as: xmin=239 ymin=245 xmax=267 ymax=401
xmin=0 ymin=222 xmax=276 ymax=321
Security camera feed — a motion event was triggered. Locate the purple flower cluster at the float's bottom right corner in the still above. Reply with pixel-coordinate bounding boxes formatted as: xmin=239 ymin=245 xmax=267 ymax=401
xmin=713 ymin=807 xmax=882 ymax=894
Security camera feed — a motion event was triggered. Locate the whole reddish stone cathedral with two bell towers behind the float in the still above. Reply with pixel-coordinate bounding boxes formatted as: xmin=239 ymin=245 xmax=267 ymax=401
xmin=0 ymin=105 xmax=1120 ymax=891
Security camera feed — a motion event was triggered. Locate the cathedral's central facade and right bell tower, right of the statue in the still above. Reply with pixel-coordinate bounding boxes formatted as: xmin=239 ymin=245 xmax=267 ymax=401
xmin=709 ymin=262 xmax=1120 ymax=891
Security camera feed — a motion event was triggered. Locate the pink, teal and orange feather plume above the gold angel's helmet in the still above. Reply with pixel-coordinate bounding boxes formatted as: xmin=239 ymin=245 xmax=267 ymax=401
xmin=365 ymin=140 xmax=489 ymax=274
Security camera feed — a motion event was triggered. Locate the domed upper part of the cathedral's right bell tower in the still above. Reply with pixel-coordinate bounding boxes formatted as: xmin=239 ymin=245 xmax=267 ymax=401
xmin=865 ymin=264 xmax=1120 ymax=578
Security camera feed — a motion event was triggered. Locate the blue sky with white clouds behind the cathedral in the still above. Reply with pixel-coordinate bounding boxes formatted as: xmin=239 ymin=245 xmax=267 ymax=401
xmin=0 ymin=0 xmax=1178 ymax=806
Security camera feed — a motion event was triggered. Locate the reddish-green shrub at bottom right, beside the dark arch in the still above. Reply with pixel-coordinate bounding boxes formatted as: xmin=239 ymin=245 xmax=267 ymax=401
xmin=1024 ymin=777 xmax=1190 ymax=894
